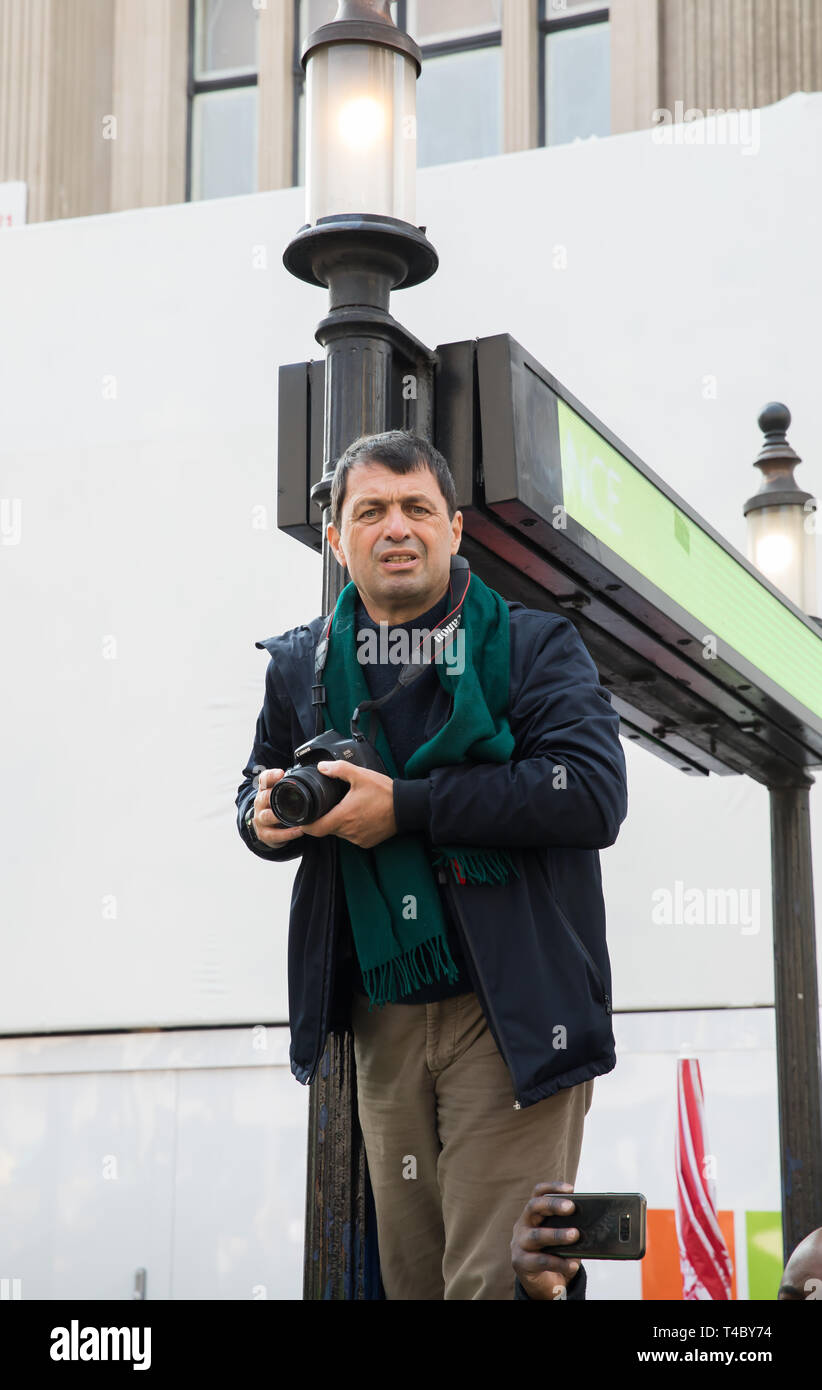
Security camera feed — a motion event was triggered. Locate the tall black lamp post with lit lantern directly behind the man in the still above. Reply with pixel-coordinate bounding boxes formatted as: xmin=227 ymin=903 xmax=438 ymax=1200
xmin=282 ymin=0 xmax=438 ymax=1300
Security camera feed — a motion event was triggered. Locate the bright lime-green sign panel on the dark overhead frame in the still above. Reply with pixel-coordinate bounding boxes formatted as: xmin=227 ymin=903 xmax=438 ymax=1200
xmin=558 ymin=399 xmax=822 ymax=717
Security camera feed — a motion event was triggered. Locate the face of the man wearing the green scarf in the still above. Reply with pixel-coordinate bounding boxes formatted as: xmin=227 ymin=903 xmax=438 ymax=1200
xmin=328 ymin=461 xmax=462 ymax=623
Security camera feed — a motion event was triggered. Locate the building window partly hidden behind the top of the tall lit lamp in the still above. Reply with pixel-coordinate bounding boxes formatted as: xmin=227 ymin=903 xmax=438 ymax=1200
xmin=293 ymin=0 xmax=502 ymax=183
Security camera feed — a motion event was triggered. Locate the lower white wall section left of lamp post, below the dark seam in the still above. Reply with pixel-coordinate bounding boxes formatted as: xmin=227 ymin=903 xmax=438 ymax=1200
xmin=0 ymin=1027 xmax=307 ymax=1301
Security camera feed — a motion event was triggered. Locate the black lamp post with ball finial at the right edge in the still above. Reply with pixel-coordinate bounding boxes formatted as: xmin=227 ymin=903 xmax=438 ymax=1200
xmin=744 ymin=402 xmax=822 ymax=1259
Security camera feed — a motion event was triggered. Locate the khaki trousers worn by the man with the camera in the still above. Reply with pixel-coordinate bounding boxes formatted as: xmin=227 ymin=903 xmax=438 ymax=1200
xmin=352 ymin=994 xmax=594 ymax=1300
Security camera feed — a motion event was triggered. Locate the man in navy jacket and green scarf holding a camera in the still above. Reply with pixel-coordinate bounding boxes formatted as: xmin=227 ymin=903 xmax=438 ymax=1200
xmin=236 ymin=431 xmax=627 ymax=1300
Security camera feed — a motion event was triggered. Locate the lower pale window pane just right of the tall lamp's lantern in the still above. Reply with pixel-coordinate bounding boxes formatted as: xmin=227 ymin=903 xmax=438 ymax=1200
xmin=417 ymin=47 xmax=502 ymax=168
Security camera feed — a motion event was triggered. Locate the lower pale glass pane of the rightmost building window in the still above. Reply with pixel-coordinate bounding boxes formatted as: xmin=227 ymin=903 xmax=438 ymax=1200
xmin=545 ymin=22 xmax=611 ymax=145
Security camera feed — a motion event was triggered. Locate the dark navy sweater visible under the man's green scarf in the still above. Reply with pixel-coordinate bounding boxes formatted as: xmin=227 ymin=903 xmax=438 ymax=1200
xmin=352 ymin=594 xmax=474 ymax=1004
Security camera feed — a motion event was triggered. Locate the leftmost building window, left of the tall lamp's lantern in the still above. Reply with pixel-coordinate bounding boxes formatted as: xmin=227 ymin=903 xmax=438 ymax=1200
xmin=186 ymin=0 xmax=260 ymax=202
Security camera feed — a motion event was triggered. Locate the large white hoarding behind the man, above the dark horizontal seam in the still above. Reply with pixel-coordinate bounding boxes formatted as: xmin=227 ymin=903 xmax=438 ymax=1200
xmin=0 ymin=86 xmax=822 ymax=1033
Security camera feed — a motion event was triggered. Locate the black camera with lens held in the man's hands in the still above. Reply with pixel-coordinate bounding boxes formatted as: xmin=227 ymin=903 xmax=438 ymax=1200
xmin=270 ymin=728 xmax=385 ymax=826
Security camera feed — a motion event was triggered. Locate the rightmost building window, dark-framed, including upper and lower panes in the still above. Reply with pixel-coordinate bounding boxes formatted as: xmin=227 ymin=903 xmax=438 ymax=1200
xmin=540 ymin=0 xmax=611 ymax=145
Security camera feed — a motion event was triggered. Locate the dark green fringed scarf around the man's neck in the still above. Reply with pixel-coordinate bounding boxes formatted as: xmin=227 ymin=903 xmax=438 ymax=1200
xmin=324 ymin=574 xmax=519 ymax=1008
